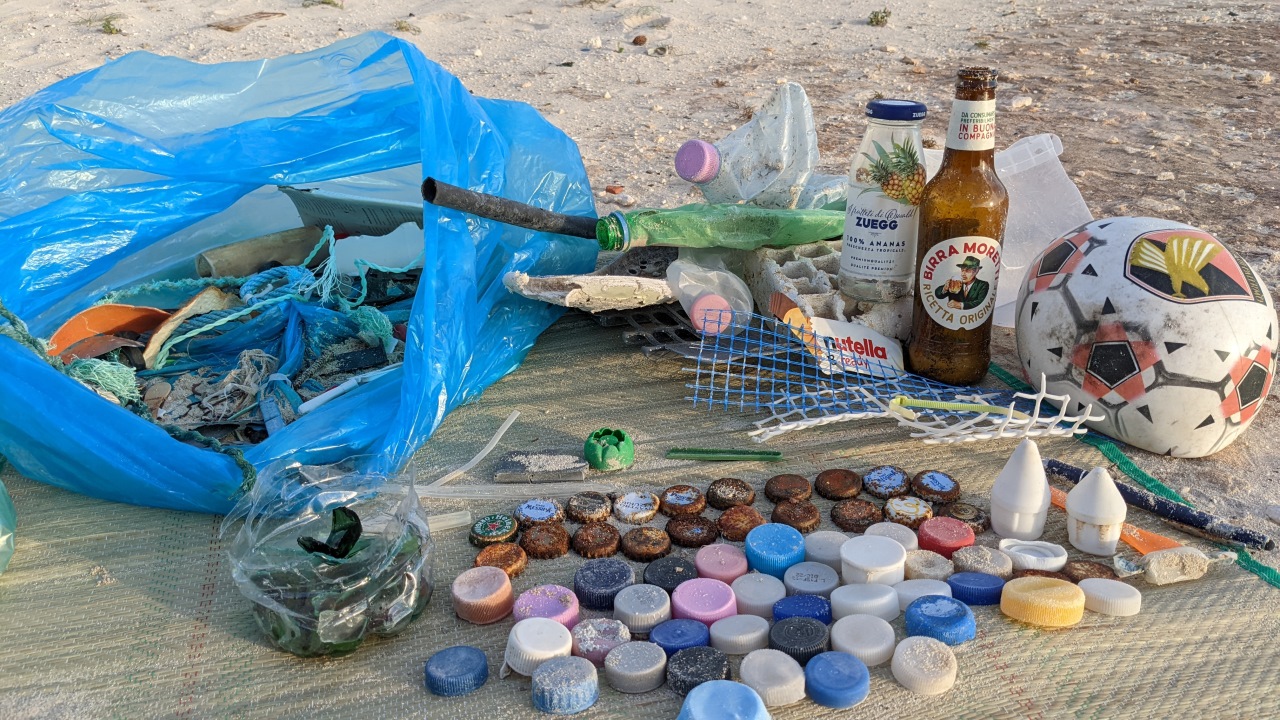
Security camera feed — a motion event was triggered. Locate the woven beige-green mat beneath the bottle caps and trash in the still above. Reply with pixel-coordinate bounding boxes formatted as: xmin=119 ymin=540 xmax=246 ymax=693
xmin=0 ymin=315 xmax=1280 ymax=720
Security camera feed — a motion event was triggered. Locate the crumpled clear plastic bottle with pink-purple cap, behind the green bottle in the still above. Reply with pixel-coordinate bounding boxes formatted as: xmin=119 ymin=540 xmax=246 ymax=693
xmin=676 ymin=82 xmax=845 ymax=209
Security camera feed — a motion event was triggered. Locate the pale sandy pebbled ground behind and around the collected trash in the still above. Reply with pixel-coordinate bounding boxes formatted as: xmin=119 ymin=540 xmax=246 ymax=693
xmin=0 ymin=0 xmax=1280 ymax=566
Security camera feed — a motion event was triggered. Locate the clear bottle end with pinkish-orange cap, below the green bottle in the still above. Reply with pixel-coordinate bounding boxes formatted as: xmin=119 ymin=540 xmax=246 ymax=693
xmin=667 ymin=250 xmax=754 ymax=334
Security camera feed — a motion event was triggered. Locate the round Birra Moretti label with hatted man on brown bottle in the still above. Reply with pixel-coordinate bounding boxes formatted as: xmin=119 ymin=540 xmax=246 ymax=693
xmin=915 ymin=236 xmax=1000 ymax=331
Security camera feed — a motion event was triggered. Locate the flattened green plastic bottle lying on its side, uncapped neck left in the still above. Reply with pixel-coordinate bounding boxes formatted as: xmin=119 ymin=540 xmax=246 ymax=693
xmin=595 ymin=204 xmax=845 ymax=250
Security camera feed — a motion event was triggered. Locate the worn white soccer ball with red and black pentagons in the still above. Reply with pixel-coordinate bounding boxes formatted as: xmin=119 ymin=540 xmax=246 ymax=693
xmin=1016 ymin=218 xmax=1280 ymax=457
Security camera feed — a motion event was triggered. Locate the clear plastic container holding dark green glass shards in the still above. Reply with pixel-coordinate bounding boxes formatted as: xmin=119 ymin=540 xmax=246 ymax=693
xmin=223 ymin=457 xmax=433 ymax=657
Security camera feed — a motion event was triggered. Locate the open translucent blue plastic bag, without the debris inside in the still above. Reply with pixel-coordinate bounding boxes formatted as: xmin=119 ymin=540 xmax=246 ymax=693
xmin=0 ymin=33 xmax=595 ymax=512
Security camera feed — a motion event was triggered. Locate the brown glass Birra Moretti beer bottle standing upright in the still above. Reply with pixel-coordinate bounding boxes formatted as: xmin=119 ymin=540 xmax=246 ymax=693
xmin=906 ymin=68 xmax=1009 ymax=386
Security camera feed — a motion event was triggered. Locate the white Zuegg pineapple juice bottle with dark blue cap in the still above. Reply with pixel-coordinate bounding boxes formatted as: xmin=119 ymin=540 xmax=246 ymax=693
xmin=840 ymin=100 xmax=928 ymax=302
